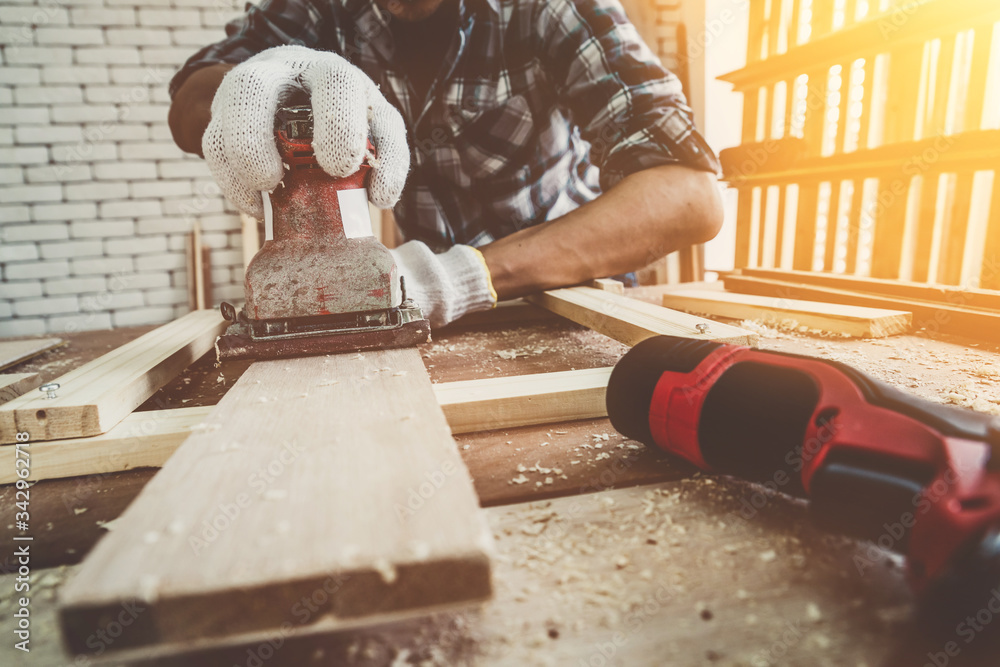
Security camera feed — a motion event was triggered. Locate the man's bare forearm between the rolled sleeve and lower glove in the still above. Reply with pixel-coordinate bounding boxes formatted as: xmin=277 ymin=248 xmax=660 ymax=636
xmin=481 ymin=165 xmax=723 ymax=299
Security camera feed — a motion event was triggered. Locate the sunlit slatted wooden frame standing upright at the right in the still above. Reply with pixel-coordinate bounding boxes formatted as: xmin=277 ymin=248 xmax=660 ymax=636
xmin=720 ymin=0 xmax=1000 ymax=288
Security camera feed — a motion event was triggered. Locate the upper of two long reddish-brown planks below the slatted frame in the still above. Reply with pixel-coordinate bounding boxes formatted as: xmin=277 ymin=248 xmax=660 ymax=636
xmin=743 ymin=269 xmax=1000 ymax=311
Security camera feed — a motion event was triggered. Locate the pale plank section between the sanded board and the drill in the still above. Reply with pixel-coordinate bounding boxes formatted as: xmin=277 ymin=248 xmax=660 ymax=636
xmin=434 ymin=368 xmax=611 ymax=433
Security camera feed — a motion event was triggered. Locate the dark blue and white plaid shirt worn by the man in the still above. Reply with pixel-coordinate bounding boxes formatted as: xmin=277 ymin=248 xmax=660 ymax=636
xmin=170 ymin=0 xmax=718 ymax=249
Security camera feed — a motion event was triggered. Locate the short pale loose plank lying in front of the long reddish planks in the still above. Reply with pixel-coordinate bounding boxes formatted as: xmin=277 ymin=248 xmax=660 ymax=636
xmin=663 ymin=289 xmax=912 ymax=338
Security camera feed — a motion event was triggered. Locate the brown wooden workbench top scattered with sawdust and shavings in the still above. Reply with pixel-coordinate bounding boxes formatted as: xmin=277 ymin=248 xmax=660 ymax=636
xmin=0 ymin=298 xmax=1000 ymax=667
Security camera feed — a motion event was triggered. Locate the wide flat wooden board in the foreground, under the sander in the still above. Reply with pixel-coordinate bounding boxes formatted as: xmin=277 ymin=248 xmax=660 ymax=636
xmin=60 ymin=349 xmax=492 ymax=659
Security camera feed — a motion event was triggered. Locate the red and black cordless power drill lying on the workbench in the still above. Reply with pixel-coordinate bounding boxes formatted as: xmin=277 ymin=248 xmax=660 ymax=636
xmin=607 ymin=336 xmax=1000 ymax=608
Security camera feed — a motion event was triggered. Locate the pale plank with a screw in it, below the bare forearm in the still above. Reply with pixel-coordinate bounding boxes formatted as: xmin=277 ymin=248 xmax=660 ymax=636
xmin=525 ymin=287 xmax=758 ymax=346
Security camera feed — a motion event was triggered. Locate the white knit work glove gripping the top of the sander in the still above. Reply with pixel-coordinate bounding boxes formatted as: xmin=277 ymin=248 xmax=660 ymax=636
xmin=201 ymin=46 xmax=410 ymax=219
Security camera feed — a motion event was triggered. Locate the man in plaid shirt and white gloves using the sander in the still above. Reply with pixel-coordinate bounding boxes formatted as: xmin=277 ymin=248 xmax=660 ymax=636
xmin=170 ymin=0 xmax=722 ymax=326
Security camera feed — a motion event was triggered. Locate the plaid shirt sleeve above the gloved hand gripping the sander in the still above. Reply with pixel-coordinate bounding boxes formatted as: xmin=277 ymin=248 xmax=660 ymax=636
xmin=170 ymin=0 xmax=338 ymax=98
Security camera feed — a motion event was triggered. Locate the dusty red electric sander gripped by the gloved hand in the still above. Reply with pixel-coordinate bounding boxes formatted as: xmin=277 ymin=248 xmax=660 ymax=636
xmin=217 ymin=105 xmax=430 ymax=359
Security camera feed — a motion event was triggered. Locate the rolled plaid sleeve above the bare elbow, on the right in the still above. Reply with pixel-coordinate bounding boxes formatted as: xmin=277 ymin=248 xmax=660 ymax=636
xmin=534 ymin=0 xmax=719 ymax=191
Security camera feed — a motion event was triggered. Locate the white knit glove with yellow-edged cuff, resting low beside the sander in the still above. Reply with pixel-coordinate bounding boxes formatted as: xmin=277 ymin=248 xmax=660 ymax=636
xmin=390 ymin=241 xmax=497 ymax=328
